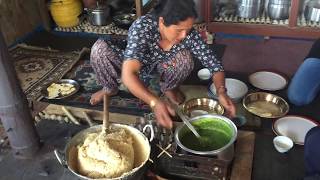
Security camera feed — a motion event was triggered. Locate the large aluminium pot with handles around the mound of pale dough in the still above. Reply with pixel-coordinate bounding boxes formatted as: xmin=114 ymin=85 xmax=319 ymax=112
xmin=54 ymin=124 xmax=153 ymax=180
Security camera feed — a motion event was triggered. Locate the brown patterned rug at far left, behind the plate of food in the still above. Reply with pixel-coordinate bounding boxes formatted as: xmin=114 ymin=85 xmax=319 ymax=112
xmin=9 ymin=44 xmax=86 ymax=100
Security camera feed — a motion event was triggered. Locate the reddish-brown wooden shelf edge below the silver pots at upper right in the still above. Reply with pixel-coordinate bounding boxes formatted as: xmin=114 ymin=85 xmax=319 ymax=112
xmin=208 ymin=22 xmax=320 ymax=39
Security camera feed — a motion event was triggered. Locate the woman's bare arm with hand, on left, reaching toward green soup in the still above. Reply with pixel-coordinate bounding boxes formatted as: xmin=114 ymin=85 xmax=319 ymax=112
xmin=121 ymin=60 xmax=174 ymax=128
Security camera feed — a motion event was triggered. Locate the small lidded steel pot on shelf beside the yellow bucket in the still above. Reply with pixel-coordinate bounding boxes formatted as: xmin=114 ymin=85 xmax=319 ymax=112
xmin=86 ymin=2 xmax=110 ymax=26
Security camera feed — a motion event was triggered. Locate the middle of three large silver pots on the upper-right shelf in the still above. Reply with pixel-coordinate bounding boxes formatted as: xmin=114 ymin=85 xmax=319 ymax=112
xmin=268 ymin=3 xmax=290 ymax=20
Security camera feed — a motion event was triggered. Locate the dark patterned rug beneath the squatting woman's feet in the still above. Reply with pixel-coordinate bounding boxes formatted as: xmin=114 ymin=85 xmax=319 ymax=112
xmin=42 ymin=55 xmax=160 ymax=115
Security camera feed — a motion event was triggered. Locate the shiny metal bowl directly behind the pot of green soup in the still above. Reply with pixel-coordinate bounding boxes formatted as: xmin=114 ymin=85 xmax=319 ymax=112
xmin=182 ymin=98 xmax=224 ymax=118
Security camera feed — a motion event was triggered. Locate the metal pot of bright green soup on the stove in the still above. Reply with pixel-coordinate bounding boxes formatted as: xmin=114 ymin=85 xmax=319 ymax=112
xmin=174 ymin=114 xmax=237 ymax=161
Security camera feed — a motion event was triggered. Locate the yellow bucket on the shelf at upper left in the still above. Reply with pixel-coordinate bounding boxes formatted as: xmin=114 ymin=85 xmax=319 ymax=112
xmin=50 ymin=0 xmax=82 ymax=27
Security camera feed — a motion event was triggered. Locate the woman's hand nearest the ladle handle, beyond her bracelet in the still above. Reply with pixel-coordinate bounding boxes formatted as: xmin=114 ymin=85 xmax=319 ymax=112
xmin=153 ymin=100 xmax=175 ymax=129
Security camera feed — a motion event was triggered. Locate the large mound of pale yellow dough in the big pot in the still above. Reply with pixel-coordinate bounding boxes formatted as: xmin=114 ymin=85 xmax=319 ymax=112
xmin=77 ymin=129 xmax=134 ymax=178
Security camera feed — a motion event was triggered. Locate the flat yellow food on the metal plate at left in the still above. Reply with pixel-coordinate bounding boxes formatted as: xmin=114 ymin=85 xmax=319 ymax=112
xmin=47 ymin=83 xmax=76 ymax=99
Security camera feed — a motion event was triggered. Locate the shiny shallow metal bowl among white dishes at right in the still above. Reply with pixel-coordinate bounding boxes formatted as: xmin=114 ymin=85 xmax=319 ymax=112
xmin=242 ymin=92 xmax=289 ymax=118
